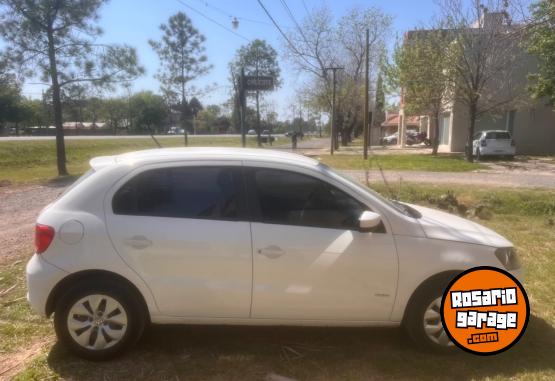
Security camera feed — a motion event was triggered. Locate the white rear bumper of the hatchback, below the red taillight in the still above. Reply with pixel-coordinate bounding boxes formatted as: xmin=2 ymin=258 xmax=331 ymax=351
xmin=26 ymin=254 xmax=68 ymax=316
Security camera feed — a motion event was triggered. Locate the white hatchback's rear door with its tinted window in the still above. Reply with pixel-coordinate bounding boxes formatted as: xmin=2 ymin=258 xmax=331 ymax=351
xmin=105 ymin=162 xmax=252 ymax=318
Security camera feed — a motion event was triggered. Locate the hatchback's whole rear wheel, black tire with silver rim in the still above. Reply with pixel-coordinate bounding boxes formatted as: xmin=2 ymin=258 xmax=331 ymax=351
xmin=54 ymin=281 xmax=145 ymax=360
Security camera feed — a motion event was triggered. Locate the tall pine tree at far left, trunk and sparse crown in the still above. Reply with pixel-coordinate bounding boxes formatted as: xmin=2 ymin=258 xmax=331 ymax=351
xmin=0 ymin=0 xmax=143 ymax=175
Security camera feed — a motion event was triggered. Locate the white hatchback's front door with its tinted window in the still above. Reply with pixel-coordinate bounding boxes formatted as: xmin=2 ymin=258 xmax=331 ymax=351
xmin=246 ymin=168 xmax=397 ymax=321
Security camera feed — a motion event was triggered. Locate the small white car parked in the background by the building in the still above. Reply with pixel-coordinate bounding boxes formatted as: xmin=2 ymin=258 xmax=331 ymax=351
xmin=472 ymin=130 xmax=516 ymax=160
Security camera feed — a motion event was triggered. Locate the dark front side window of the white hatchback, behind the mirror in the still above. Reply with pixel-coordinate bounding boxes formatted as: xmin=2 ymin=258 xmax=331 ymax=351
xmin=252 ymin=169 xmax=368 ymax=230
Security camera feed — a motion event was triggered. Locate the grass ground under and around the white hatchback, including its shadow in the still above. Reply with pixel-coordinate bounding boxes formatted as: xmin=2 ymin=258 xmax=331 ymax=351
xmin=0 ymin=184 xmax=555 ymax=380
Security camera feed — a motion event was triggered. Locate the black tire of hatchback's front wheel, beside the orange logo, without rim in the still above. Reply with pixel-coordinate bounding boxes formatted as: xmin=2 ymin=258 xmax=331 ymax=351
xmin=403 ymin=277 xmax=456 ymax=354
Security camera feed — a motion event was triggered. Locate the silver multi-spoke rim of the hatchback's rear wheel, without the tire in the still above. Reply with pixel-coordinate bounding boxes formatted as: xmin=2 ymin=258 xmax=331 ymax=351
xmin=67 ymin=294 xmax=128 ymax=350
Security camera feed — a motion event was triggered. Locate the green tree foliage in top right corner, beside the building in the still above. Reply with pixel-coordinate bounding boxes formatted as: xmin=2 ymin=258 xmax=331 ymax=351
xmin=526 ymin=0 xmax=555 ymax=106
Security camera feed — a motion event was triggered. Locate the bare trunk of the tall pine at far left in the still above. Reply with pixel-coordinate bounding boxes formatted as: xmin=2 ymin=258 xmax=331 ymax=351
xmin=48 ymin=27 xmax=68 ymax=176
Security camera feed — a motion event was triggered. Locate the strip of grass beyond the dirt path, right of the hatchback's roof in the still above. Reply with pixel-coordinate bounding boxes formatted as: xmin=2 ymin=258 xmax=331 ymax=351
xmin=319 ymin=154 xmax=488 ymax=172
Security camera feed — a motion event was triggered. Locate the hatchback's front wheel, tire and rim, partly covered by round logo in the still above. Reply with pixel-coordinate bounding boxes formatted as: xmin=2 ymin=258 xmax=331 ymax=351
xmin=403 ymin=282 xmax=455 ymax=353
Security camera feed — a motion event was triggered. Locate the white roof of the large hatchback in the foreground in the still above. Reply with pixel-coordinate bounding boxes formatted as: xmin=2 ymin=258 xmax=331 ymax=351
xmin=90 ymin=147 xmax=319 ymax=170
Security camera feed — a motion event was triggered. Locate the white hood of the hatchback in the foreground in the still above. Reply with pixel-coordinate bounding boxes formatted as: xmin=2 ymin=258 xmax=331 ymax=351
xmin=409 ymin=204 xmax=513 ymax=247
